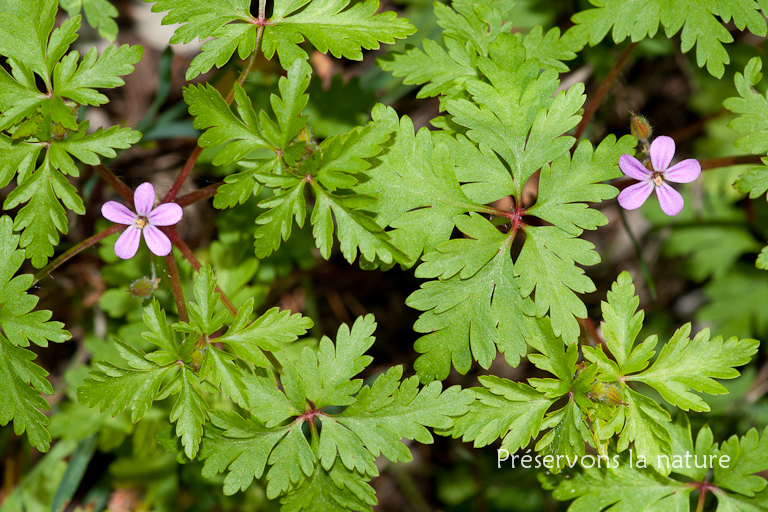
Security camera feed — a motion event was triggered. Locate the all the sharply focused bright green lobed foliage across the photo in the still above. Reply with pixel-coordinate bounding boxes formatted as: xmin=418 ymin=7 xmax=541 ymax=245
xmin=0 ymin=0 xmax=768 ymax=511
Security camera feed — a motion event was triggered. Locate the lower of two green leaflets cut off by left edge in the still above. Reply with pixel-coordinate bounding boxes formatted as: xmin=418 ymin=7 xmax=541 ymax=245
xmin=0 ymin=334 xmax=53 ymax=452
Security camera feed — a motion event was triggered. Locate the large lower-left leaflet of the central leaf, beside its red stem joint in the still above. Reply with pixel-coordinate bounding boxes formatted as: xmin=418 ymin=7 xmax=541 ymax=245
xmin=406 ymin=213 xmax=533 ymax=382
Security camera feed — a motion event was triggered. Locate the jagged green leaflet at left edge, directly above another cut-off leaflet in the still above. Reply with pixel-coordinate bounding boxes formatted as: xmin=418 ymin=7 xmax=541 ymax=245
xmin=0 ymin=215 xmax=72 ymax=347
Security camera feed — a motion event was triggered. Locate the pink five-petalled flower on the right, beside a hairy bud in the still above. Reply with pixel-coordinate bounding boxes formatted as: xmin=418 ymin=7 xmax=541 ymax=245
xmin=619 ymin=135 xmax=701 ymax=216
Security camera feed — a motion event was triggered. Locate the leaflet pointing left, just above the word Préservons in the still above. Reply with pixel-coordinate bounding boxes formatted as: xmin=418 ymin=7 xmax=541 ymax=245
xmin=446 ymin=375 xmax=554 ymax=453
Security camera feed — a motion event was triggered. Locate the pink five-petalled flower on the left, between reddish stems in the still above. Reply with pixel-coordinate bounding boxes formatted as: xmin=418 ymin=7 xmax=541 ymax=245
xmin=101 ymin=183 xmax=183 ymax=260
